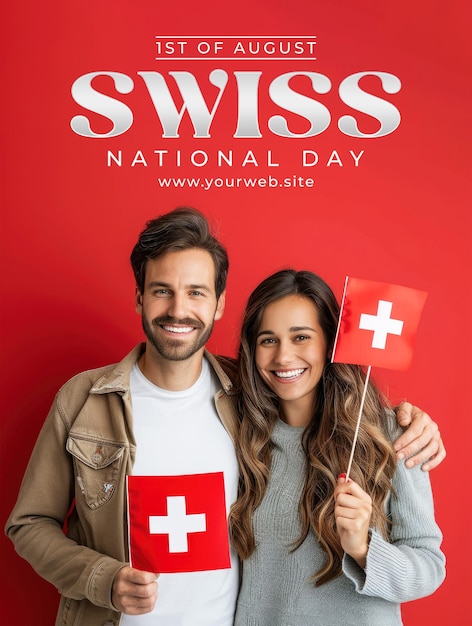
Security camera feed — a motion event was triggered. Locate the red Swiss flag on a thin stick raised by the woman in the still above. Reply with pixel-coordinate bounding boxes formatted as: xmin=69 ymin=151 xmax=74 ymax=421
xmin=331 ymin=277 xmax=427 ymax=370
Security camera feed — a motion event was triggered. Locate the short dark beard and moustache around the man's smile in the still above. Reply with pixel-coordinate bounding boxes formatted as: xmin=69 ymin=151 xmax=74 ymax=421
xmin=142 ymin=315 xmax=214 ymax=361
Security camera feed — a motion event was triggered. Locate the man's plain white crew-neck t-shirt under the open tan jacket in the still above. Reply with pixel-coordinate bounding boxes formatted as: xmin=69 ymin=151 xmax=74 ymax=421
xmin=121 ymin=359 xmax=239 ymax=626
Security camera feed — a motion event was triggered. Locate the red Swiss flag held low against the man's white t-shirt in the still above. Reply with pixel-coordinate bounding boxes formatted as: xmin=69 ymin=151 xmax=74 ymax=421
xmin=127 ymin=472 xmax=231 ymax=573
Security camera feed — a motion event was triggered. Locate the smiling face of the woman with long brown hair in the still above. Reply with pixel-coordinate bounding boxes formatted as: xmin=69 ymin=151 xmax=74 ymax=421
xmin=255 ymin=295 xmax=327 ymax=423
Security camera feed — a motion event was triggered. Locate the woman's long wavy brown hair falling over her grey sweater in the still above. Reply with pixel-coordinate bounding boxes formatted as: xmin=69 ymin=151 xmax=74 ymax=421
xmin=229 ymin=270 xmax=395 ymax=585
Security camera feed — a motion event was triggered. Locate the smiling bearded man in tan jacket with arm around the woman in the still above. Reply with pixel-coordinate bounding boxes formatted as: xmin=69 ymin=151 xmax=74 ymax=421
xmin=6 ymin=208 xmax=445 ymax=626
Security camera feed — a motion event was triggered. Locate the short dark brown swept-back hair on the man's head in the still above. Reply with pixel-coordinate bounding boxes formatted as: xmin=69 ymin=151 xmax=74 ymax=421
xmin=130 ymin=206 xmax=229 ymax=298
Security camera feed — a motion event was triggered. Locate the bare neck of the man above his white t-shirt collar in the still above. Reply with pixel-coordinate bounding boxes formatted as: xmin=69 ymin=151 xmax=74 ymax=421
xmin=138 ymin=344 xmax=204 ymax=391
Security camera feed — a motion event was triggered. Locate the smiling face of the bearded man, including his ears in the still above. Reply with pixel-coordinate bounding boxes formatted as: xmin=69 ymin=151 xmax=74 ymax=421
xmin=136 ymin=248 xmax=225 ymax=361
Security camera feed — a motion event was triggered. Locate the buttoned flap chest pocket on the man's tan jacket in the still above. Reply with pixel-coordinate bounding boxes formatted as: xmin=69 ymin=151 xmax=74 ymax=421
xmin=66 ymin=435 xmax=125 ymax=509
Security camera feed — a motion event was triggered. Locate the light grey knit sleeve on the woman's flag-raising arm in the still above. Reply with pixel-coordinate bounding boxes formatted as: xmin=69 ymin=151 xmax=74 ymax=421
xmin=343 ymin=461 xmax=446 ymax=602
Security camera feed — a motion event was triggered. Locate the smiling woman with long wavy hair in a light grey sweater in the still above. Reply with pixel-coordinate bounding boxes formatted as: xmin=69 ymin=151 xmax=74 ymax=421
xmin=230 ymin=270 xmax=445 ymax=626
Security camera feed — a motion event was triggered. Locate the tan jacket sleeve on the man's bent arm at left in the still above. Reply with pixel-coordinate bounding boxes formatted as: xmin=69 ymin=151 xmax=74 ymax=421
xmin=5 ymin=390 xmax=125 ymax=609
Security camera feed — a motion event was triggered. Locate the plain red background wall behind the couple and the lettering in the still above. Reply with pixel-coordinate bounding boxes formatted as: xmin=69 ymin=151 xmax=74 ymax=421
xmin=0 ymin=0 xmax=472 ymax=626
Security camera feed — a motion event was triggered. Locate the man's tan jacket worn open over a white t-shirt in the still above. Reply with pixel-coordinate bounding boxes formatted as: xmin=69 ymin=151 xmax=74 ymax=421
xmin=5 ymin=344 xmax=237 ymax=626
